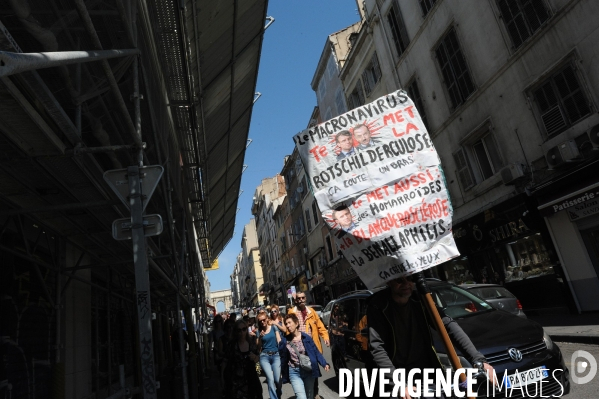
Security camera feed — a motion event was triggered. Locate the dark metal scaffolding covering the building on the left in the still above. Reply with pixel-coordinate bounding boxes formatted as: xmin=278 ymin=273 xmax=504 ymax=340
xmin=0 ymin=0 xmax=270 ymax=398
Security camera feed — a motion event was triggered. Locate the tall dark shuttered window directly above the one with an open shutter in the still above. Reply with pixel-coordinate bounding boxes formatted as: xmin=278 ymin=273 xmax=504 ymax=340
xmin=435 ymin=28 xmax=474 ymax=109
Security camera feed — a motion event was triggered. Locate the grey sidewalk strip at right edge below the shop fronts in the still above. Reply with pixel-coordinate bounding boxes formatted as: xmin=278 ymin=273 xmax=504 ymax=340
xmin=527 ymin=312 xmax=599 ymax=344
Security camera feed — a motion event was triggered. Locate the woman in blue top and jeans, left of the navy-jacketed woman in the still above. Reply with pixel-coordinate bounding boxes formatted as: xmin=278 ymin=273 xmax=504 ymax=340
xmin=258 ymin=310 xmax=281 ymax=399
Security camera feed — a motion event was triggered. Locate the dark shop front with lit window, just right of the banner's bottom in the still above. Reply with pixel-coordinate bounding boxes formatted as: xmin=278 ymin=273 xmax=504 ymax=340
xmin=437 ymin=194 xmax=574 ymax=311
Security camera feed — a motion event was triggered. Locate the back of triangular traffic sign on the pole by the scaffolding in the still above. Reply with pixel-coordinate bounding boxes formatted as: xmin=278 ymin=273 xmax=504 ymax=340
xmin=104 ymin=165 xmax=164 ymax=212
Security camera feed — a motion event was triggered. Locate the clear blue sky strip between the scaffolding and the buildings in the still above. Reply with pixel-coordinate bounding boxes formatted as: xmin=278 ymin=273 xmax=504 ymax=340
xmin=206 ymin=0 xmax=360 ymax=296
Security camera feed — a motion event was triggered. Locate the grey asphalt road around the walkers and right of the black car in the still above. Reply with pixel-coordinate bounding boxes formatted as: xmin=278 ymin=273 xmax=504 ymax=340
xmin=260 ymin=342 xmax=599 ymax=399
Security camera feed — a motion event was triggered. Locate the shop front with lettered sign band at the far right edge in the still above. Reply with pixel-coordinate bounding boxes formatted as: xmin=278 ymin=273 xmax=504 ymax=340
xmin=538 ymin=169 xmax=599 ymax=312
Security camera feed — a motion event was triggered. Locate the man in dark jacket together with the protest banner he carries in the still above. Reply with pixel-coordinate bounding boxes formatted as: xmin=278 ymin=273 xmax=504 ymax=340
xmin=294 ymin=90 xmax=492 ymax=397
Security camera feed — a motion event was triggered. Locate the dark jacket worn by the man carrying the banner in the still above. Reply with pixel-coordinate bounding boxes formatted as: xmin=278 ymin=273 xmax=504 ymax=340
xmin=367 ymin=288 xmax=486 ymax=372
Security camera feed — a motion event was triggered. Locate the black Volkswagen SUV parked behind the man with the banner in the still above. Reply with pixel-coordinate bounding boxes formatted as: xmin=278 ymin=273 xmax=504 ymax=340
xmin=327 ymin=279 xmax=570 ymax=398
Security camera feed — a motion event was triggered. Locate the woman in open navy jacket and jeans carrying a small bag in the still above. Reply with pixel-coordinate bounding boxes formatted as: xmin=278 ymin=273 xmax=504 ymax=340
xmin=277 ymin=314 xmax=330 ymax=399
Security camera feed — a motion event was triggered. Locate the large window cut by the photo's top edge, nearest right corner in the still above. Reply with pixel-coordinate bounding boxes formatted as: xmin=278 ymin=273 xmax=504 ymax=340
xmin=497 ymin=0 xmax=549 ymax=49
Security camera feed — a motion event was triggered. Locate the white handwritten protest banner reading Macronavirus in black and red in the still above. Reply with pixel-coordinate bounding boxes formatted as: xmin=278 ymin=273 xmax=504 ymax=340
xmin=294 ymin=90 xmax=459 ymax=288
